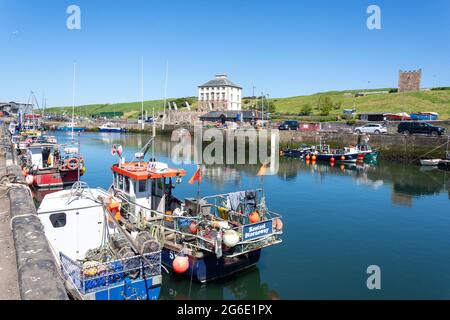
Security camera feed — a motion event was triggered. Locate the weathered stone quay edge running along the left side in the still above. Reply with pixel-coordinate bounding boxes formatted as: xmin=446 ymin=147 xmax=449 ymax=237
xmin=0 ymin=125 xmax=68 ymax=300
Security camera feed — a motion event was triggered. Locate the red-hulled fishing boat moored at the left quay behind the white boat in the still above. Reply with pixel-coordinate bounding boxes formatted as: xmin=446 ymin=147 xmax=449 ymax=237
xmin=19 ymin=142 xmax=86 ymax=188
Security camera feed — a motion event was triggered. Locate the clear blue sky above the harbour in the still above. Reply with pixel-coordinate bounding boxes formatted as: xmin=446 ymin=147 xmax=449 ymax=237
xmin=0 ymin=0 xmax=450 ymax=106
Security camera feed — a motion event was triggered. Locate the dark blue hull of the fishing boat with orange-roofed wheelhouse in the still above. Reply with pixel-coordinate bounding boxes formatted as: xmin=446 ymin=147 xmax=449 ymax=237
xmin=161 ymin=248 xmax=261 ymax=283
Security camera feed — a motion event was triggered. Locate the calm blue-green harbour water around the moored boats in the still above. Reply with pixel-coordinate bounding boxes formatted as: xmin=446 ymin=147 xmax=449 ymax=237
xmin=46 ymin=133 xmax=450 ymax=299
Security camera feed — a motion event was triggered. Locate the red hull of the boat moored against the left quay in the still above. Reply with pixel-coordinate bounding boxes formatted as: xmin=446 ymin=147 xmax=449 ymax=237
xmin=33 ymin=168 xmax=78 ymax=188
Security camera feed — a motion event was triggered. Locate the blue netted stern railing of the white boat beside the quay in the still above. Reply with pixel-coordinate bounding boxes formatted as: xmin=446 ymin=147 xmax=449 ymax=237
xmin=60 ymin=251 xmax=161 ymax=294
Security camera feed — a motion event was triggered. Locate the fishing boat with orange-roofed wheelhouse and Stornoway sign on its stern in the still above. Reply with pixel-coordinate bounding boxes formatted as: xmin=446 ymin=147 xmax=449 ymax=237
xmin=110 ymin=144 xmax=283 ymax=283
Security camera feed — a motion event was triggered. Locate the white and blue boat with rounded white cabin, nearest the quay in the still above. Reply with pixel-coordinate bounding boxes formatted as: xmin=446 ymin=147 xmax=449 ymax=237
xmin=37 ymin=182 xmax=162 ymax=300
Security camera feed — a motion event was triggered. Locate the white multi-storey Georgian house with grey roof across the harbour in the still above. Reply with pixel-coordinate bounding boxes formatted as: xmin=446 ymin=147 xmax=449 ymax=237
xmin=198 ymin=74 xmax=242 ymax=111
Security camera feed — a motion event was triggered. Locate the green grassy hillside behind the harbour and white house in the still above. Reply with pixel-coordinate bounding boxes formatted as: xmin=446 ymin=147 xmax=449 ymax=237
xmin=47 ymin=89 xmax=450 ymax=119
